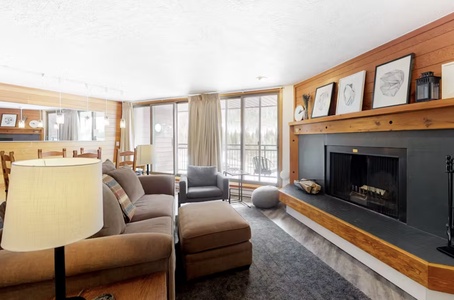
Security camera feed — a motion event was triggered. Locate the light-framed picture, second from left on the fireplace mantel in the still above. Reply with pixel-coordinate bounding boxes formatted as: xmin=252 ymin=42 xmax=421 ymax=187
xmin=336 ymin=71 xmax=366 ymax=115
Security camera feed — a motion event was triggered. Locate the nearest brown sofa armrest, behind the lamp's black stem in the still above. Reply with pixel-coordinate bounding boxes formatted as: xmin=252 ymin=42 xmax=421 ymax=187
xmin=0 ymin=233 xmax=173 ymax=288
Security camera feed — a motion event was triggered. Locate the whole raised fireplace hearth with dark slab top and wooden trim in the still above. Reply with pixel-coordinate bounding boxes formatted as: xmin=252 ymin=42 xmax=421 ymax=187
xmin=279 ymin=185 xmax=454 ymax=300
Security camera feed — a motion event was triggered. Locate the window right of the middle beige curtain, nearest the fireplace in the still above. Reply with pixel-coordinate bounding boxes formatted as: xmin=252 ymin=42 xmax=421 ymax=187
xmin=221 ymin=93 xmax=278 ymax=184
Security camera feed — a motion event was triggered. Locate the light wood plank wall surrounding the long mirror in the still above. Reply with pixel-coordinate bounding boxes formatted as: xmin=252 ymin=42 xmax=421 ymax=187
xmin=0 ymin=83 xmax=121 ymax=202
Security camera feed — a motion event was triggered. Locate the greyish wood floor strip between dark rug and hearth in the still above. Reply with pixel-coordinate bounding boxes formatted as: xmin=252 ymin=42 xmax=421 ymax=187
xmin=232 ymin=197 xmax=415 ymax=300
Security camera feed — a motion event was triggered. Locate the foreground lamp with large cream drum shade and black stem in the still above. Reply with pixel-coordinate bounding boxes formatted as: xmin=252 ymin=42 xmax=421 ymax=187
xmin=1 ymin=158 xmax=103 ymax=300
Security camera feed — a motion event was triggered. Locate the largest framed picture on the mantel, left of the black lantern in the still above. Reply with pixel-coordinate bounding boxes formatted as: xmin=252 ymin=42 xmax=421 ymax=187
xmin=372 ymin=53 xmax=415 ymax=108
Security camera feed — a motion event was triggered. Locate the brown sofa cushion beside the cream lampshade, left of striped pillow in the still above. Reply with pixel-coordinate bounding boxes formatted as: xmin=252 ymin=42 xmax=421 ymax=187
xmin=92 ymin=184 xmax=126 ymax=238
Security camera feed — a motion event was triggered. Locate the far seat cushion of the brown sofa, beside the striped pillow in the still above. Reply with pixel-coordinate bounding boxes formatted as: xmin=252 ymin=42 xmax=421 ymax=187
xmin=131 ymin=194 xmax=175 ymax=222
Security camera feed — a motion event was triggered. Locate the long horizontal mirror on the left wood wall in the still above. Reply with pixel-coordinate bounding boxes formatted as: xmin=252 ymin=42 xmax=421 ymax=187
xmin=0 ymin=101 xmax=105 ymax=141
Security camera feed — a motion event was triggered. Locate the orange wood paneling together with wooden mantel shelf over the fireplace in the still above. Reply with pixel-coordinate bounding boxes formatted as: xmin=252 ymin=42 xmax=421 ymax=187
xmin=290 ymin=13 xmax=454 ymax=180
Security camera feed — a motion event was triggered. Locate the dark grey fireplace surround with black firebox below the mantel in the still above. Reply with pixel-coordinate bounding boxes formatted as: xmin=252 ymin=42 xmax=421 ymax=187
xmin=298 ymin=130 xmax=454 ymax=238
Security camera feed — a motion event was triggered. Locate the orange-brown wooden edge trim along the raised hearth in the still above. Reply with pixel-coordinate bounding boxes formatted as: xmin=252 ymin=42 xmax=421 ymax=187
xmin=279 ymin=191 xmax=454 ymax=294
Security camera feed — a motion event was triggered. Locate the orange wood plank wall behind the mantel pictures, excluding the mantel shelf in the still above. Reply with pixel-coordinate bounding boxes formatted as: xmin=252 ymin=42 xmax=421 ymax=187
xmin=290 ymin=13 xmax=454 ymax=180
